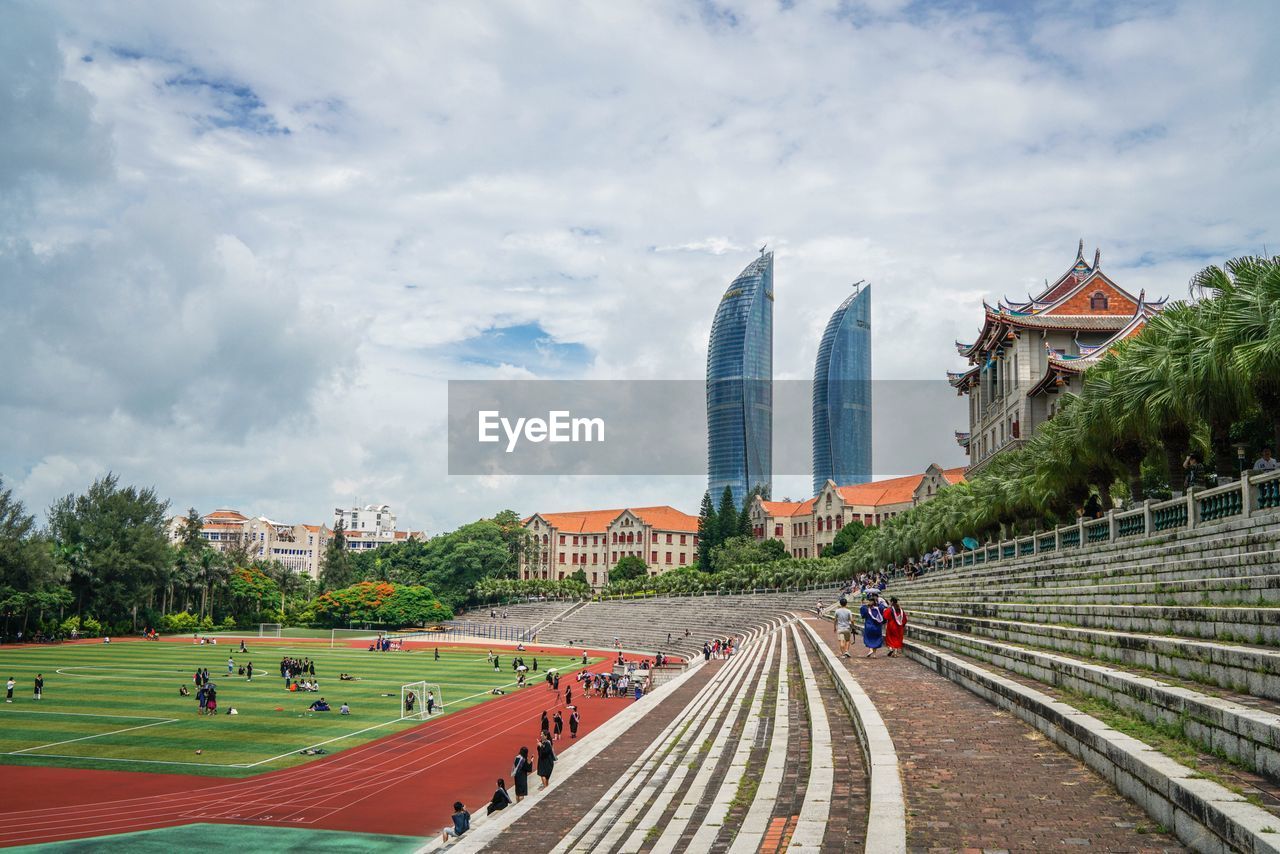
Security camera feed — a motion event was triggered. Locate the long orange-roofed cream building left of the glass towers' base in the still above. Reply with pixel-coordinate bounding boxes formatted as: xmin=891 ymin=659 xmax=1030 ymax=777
xmin=520 ymin=504 xmax=698 ymax=588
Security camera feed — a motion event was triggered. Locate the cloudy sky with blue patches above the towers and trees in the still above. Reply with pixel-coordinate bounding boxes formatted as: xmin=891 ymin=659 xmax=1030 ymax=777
xmin=0 ymin=0 xmax=1280 ymax=531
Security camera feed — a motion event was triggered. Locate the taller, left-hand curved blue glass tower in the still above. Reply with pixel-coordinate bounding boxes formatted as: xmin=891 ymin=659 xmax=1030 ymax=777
xmin=707 ymin=252 xmax=773 ymax=507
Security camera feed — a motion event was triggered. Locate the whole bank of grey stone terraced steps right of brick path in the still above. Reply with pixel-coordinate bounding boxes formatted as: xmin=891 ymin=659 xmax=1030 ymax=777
xmin=890 ymin=512 xmax=1280 ymax=851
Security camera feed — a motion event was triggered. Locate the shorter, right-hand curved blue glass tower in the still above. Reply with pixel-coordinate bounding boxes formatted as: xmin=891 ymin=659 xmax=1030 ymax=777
xmin=813 ymin=287 xmax=872 ymax=495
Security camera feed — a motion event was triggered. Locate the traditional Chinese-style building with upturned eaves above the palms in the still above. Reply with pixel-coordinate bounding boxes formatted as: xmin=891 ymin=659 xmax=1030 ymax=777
xmin=947 ymin=239 xmax=1166 ymax=474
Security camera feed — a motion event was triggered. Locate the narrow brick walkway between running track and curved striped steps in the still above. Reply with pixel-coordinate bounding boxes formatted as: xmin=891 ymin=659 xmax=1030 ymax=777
xmin=483 ymin=659 xmax=726 ymax=854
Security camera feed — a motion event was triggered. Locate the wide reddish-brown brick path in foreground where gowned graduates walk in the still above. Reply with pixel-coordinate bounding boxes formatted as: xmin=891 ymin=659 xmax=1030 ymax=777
xmin=809 ymin=618 xmax=1185 ymax=854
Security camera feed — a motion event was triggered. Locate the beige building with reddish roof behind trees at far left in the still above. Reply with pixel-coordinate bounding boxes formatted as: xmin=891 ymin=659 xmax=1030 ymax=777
xmin=169 ymin=510 xmax=333 ymax=579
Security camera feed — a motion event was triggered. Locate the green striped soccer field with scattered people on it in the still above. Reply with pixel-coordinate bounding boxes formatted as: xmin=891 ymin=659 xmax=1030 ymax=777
xmin=0 ymin=639 xmax=588 ymax=777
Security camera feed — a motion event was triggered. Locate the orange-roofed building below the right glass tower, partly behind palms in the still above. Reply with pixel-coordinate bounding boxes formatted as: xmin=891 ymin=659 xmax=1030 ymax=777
xmin=750 ymin=463 xmax=964 ymax=557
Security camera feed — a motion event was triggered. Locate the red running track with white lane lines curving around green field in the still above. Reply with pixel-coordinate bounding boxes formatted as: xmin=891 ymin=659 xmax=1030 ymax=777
xmin=0 ymin=648 xmax=660 ymax=846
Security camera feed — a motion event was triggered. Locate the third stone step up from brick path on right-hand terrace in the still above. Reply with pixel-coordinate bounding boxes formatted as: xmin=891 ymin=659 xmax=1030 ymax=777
xmin=908 ymin=603 xmax=1280 ymax=700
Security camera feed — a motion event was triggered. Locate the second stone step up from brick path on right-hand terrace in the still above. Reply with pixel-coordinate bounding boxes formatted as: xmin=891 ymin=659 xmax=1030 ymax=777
xmin=911 ymin=614 xmax=1280 ymax=788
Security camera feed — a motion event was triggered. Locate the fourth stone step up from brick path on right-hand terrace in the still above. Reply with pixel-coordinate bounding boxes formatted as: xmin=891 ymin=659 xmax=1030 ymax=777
xmin=896 ymin=592 xmax=1280 ymax=647
